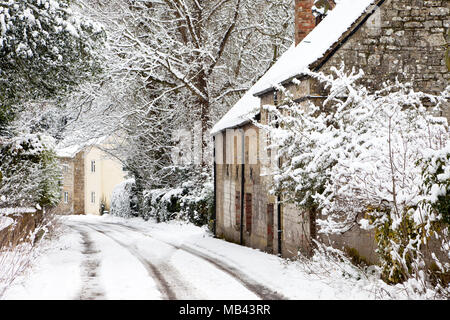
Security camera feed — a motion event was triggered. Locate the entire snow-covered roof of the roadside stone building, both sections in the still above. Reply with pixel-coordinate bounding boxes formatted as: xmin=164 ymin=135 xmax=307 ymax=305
xmin=211 ymin=0 xmax=375 ymax=135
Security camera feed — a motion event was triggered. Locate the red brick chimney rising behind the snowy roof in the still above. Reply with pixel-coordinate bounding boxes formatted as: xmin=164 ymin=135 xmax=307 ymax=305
xmin=295 ymin=0 xmax=316 ymax=45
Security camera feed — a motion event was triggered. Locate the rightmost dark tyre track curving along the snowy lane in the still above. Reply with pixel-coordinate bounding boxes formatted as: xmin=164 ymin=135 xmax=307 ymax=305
xmin=103 ymin=222 xmax=287 ymax=300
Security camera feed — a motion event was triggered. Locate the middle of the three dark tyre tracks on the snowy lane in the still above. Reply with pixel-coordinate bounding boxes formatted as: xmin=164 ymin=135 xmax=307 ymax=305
xmin=85 ymin=225 xmax=200 ymax=300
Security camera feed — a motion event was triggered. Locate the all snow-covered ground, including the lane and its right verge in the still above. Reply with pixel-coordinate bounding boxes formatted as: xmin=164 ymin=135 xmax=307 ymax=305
xmin=3 ymin=215 xmax=428 ymax=300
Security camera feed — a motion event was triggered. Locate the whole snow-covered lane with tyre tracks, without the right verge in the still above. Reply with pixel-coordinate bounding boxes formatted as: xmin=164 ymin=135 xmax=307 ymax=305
xmin=9 ymin=216 xmax=270 ymax=300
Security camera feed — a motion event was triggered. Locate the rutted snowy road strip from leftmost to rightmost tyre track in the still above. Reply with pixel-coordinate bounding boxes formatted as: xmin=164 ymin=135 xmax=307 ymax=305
xmin=67 ymin=221 xmax=283 ymax=299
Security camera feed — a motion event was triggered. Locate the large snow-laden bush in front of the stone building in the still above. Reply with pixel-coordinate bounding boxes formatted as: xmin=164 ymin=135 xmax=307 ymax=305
xmin=262 ymin=66 xmax=450 ymax=296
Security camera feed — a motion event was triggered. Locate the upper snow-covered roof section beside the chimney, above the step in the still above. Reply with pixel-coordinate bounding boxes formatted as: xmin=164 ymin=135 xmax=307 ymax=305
xmin=254 ymin=0 xmax=375 ymax=95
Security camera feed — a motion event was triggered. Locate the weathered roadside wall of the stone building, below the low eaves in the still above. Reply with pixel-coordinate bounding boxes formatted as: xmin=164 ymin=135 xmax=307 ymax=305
xmin=216 ymin=124 xmax=300 ymax=256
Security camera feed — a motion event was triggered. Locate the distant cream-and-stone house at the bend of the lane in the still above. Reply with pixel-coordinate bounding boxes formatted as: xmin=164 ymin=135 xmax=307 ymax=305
xmin=56 ymin=138 xmax=126 ymax=215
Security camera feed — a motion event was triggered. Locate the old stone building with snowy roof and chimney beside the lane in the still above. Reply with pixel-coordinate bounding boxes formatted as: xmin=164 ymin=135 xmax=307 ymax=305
xmin=212 ymin=0 xmax=450 ymax=261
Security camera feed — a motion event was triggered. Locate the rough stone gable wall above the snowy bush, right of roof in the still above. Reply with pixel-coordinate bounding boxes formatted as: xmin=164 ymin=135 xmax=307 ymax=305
xmin=320 ymin=0 xmax=450 ymax=119
